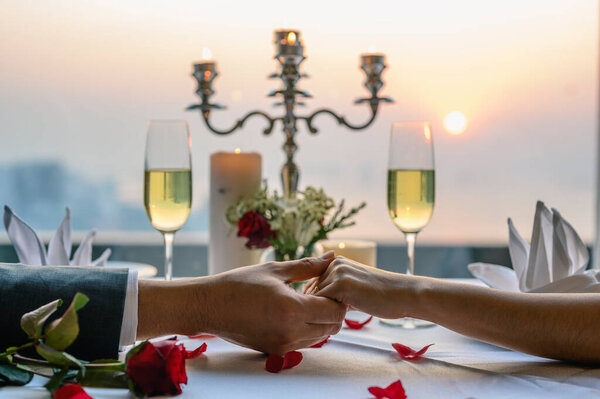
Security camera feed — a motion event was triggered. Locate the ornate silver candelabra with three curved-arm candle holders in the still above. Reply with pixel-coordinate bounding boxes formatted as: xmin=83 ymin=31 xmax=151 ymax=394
xmin=187 ymin=30 xmax=393 ymax=197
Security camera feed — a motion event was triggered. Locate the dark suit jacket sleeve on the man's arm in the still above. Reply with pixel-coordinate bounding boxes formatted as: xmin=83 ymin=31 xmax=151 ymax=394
xmin=0 ymin=264 xmax=128 ymax=360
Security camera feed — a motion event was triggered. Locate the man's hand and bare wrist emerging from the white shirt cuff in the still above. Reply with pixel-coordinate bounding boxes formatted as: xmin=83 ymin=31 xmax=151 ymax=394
xmin=138 ymin=253 xmax=346 ymax=354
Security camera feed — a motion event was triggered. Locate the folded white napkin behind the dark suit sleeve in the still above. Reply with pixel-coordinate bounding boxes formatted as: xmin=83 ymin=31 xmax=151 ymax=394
xmin=4 ymin=206 xmax=111 ymax=266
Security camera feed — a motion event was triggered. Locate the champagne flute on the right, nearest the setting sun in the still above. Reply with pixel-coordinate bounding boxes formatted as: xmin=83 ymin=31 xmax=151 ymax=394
xmin=384 ymin=122 xmax=435 ymax=328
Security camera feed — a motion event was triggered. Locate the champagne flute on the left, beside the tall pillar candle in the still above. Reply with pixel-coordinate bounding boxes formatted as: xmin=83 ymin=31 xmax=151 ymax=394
xmin=144 ymin=121 xmax=192 ymax=280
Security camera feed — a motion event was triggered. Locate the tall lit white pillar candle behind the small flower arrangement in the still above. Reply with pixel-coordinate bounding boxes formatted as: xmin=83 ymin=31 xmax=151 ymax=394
xmin=208 ymin=150 xmax=262 ymax=275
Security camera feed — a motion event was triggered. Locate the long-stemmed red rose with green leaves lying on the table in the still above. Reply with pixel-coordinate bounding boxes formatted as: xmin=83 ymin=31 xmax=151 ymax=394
xmin=0 ymin=293 xmax=206 ymax=399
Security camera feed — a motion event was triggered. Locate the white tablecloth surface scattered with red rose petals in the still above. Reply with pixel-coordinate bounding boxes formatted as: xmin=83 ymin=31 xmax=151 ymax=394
xmin=0 ymin=282 xmax=600 ymax=399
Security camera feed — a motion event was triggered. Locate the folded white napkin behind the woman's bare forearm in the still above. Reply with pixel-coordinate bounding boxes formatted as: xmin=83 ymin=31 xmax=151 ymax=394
xmin=469 ymin=201 xmax=600 ymax=292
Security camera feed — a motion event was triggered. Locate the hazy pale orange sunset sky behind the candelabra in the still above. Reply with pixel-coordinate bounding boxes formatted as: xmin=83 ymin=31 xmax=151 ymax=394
xmin=0 ymin=0 xmax=598 ymax=244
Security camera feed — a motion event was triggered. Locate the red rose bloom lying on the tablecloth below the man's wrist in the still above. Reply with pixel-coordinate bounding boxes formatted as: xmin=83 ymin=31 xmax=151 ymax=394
xmin=126 ymin=339 xmax=206 ymax=396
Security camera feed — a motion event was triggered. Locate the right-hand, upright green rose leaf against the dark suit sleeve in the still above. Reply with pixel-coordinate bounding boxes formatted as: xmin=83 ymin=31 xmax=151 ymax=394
xmin=44 ymin=292 xmax=89 ymax=351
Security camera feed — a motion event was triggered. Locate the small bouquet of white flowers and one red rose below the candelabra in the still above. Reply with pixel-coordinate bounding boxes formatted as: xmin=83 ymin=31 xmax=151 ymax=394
xmin=225 ymin=185 xmax=367 ymax=261
